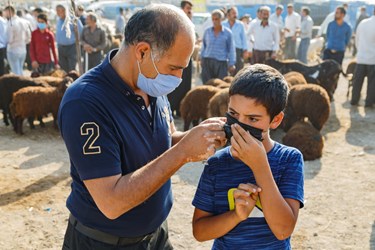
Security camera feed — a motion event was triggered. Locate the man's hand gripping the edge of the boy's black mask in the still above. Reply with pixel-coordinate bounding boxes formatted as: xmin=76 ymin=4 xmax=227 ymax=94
xmin=176 ymin=122 xmax=225 ymax=162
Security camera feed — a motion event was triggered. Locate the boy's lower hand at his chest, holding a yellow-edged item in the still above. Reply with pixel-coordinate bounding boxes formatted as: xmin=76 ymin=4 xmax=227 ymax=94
xmin=233 ymin=183 xmax=261 ymax=221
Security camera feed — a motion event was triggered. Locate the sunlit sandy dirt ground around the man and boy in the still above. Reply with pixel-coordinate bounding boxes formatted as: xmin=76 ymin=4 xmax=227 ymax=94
xmin=0 ymin=57 xmax=375 ymax=250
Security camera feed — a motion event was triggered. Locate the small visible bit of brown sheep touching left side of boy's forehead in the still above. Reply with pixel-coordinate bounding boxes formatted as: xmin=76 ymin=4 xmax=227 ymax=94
xmin=208 ymin=88 xmax=229 ymax=117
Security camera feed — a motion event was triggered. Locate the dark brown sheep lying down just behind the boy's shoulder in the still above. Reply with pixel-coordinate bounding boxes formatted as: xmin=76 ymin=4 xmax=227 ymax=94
xmin=282 ymin=121 xmax=324 ymax=161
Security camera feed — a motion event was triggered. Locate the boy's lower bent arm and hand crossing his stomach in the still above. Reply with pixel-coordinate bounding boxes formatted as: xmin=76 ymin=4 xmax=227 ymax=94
xmin=193 ymin=184 xmax=261 ymax=241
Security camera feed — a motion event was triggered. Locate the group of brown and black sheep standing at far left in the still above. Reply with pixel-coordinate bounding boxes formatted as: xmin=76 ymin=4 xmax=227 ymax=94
xmin=0 ymin=70 xmax=79 ymax=134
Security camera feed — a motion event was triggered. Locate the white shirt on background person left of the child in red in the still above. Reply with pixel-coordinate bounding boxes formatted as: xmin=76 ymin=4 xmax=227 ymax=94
xmin=7 ymin=16 xmax=31 ymax=54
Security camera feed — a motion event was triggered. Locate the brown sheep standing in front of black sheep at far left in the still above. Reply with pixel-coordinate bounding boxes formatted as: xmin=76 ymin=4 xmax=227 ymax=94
xmin=10 ymin=77 xmax=73 ymax=134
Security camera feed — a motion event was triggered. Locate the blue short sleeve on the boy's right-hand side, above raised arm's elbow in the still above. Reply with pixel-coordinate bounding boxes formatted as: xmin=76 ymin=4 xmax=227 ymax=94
xmin=278 ymin=150 xmax=304 ymax=208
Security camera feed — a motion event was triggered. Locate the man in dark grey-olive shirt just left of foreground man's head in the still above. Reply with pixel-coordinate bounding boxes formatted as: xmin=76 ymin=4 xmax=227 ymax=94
xmin=81 ymin=13 xmax=106 ymax=71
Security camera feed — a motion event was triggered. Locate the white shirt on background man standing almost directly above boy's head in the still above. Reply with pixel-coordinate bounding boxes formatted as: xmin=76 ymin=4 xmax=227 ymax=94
xmin=247 ymin=20 xmax=280 ymax=51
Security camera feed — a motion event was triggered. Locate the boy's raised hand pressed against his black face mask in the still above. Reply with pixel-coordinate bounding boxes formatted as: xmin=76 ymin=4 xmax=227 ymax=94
xmin=230 ymin=124 xmax=268 ymax=171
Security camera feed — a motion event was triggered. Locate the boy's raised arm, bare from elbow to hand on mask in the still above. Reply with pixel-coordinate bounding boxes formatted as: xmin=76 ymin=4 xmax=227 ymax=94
xmin=231 ymin=124 xmax=300 ymax=240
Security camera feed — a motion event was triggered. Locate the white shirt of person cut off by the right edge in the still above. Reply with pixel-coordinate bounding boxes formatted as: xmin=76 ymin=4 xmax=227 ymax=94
xmin=356 ymin=15 xmax=375 ymax=65
